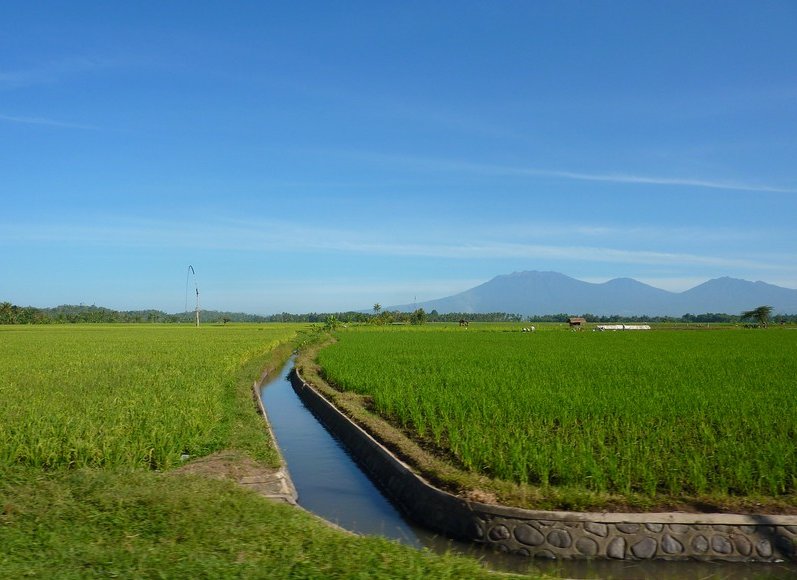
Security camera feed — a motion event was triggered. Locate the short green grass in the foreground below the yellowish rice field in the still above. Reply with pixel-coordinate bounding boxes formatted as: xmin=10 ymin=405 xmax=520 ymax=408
xmin=0 ymin=466 xmax=488 ymax=579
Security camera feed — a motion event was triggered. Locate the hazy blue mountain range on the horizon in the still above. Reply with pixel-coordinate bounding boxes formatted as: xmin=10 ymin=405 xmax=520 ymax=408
xmin=388 ymin=271 xmax=797 ymax=316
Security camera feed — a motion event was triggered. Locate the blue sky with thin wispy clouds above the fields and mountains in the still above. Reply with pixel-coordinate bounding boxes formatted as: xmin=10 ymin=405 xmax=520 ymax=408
xmin=0 ymin=0 xmax=797 ymax=314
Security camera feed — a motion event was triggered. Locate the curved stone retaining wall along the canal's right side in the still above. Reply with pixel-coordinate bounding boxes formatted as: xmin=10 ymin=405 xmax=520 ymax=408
xmin=291 ymin=371 xmax=797 ymax=562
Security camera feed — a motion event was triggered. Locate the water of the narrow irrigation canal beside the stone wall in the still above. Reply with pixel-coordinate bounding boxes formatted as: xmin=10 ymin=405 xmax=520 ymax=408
xmin=260 ymin=357 xmax=797 ymax=580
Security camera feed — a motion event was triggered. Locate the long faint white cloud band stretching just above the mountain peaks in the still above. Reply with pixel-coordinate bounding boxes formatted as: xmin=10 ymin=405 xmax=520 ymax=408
xmin=0 ymin=220 xmax=797 ymax=271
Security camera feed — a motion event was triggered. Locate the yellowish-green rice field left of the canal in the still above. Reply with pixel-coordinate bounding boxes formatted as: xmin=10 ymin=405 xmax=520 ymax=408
xmin=0 ymin=324 xmax=297 ymax=469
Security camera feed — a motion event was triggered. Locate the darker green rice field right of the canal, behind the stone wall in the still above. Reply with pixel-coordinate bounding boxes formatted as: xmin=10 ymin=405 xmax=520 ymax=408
xmin=318 ymin=325 xmax=797 ymax=497
